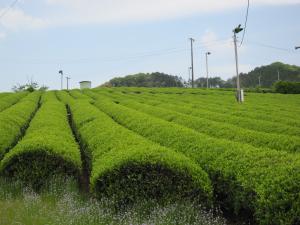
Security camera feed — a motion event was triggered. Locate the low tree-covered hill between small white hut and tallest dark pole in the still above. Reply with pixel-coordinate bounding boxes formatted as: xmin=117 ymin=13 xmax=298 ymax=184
xmin=101 ymin=72 xmax=183 ymax=87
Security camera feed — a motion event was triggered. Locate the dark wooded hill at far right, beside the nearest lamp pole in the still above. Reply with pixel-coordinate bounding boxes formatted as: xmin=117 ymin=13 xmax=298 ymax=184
xmin=238 ymin=62 xmax=300 ymax=88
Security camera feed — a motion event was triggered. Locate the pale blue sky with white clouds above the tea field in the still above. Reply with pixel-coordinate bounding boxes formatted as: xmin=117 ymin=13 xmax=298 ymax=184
xmin=0 ymin=0 xmax=300 ymax=91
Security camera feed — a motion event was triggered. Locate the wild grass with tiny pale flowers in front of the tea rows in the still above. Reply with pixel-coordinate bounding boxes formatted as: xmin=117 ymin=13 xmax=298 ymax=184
xmin=0 ymin=178 xmax=227 ymax=225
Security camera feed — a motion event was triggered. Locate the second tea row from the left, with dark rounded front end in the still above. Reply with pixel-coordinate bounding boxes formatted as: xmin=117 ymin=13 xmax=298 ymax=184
xmin=0 ymin=92 xmax=81 ymax=189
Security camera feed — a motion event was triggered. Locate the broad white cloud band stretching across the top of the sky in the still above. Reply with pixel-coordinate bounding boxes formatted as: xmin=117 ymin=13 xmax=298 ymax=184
xmin=2 ymin=0 xmax=300 ymax=30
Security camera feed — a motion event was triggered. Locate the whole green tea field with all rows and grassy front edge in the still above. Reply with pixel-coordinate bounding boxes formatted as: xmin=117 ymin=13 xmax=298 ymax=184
xmin=0 ymin=88 xmax=300 ymax=225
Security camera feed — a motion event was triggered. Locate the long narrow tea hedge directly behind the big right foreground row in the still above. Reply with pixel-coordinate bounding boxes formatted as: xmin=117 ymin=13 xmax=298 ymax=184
xmin=97 ymin=92 xmax=300 ymax=152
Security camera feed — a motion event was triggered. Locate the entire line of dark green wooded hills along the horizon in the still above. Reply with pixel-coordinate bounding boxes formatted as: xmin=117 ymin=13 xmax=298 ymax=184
xmin=101 ymin=62 xmax=300 ymax=88
